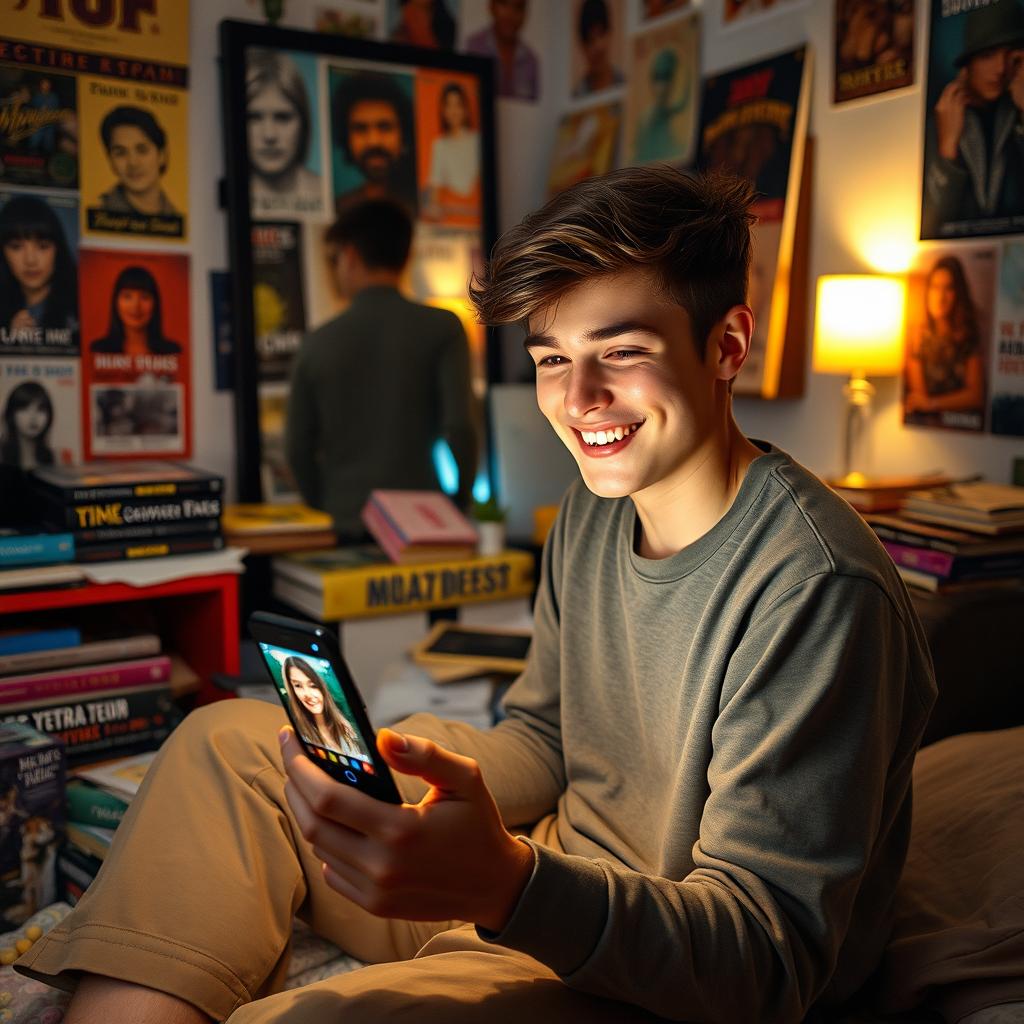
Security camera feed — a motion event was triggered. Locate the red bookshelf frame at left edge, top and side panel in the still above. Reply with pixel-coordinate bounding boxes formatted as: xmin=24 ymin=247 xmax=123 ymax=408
xmin=0 ymin=572 xmax=239 ymax=703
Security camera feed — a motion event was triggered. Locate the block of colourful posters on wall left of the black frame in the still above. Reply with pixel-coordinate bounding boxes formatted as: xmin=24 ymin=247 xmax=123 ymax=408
xmin=0 ymin=0 xmax=191 ymax=469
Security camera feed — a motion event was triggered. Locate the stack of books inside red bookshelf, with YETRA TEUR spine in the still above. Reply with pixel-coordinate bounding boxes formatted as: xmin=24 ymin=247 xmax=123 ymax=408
xmin=0 ymin=628 xmax=182 ymax=765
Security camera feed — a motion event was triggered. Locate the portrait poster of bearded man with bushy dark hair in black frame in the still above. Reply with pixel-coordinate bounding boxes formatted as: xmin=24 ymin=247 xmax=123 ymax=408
xmin=328 ymin=67 xmax=417 ymax=214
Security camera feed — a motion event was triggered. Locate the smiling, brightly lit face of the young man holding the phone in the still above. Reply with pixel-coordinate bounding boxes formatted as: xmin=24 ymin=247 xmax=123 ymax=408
xmin=526 ymin=270 xmax=718 ymax=498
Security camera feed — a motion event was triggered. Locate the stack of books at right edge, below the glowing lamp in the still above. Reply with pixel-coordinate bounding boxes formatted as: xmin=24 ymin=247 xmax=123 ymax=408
xmin=865 ymin=483 xmax=1024 ymax=593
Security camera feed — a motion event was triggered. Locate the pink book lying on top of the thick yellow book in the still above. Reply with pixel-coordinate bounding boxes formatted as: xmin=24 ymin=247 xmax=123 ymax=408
xmin=362 ymin=490 xmax=477 ymax=565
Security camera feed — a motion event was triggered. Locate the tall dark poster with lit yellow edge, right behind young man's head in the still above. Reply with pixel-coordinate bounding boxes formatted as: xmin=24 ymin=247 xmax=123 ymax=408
xmin=697 ymin=47 xmax=810 ymax=398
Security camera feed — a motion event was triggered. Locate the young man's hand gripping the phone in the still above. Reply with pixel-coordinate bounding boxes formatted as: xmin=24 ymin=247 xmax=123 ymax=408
xmin=280 ymin=727 xmax=534 ymax=932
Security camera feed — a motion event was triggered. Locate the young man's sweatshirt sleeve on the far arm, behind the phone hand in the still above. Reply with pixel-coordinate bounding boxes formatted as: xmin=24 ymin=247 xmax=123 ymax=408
xmin=396 ymin=491 xmax=565 ymax=827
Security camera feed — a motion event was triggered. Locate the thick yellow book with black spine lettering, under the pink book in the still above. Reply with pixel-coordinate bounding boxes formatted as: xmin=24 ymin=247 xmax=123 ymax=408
xmin=273 ymin=546 xmax=534 ymax=622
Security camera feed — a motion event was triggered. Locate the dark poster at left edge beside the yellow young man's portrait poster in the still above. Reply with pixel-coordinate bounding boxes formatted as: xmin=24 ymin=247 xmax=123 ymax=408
xmin=0 ymin=65 xmax=78 ymax=188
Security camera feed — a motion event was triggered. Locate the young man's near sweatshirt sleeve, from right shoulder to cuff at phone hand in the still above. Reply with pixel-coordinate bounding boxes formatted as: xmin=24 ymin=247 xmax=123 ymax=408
xmin=479 ymin=573 xmax=933 ymax=1024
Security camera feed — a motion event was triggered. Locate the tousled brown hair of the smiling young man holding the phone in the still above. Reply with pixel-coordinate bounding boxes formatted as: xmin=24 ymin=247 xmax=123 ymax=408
xmin=469 ymin=164 xmax=756 ymax=355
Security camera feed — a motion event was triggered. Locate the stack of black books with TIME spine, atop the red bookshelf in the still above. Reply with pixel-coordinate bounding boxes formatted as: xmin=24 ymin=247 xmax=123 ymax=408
xmin=31 ymin=462 xmax=224 ymax=562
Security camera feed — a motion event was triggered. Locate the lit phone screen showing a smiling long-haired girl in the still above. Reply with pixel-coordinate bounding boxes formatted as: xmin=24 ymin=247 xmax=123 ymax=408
xmin=259 ymin=643 xmax=375 ymax=775
